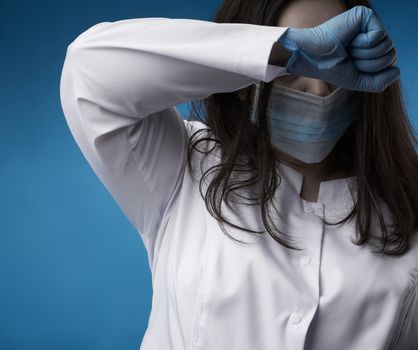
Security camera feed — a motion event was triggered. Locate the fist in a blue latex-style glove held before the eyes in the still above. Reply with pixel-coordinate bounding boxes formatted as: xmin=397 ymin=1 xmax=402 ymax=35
xmin=278 ymin=6 xmax=400 ymax=92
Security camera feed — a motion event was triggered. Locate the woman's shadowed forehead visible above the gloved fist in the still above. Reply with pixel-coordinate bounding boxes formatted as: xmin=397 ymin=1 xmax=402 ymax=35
xmin=277 ymin=0 xmax=348 ymax=28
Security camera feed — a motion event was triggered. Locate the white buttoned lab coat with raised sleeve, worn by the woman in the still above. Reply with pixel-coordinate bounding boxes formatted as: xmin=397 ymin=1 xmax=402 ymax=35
xmin=60 ymin=17 xmax=418 ymax=350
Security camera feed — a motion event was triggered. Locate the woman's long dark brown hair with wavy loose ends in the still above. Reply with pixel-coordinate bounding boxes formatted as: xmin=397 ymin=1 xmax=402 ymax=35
xmin=187 ymin=0 xmax=418 ymax=256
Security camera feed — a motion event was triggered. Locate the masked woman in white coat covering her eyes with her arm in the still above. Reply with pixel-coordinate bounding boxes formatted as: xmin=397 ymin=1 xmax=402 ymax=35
xmin=61 ymin=0 xmax=418 ymax=350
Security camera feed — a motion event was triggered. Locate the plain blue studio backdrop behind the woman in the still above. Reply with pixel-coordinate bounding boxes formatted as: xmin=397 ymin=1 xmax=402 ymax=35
xmin=0 ymin=0 xmax=418 ymax=350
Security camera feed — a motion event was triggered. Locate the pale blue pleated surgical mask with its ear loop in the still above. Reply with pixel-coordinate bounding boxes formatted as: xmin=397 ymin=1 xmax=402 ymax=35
xmin=251 ymin=83 xmax=358 ymax=163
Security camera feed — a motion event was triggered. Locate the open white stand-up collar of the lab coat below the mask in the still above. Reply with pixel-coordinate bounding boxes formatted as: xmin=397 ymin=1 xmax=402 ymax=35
xmin=279 ymin=162 xmax=357 ymax=209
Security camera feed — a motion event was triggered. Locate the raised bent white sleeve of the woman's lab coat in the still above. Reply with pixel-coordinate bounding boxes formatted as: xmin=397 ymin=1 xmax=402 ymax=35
xmin=60 ymin=17 xmax=288 ymax=260
